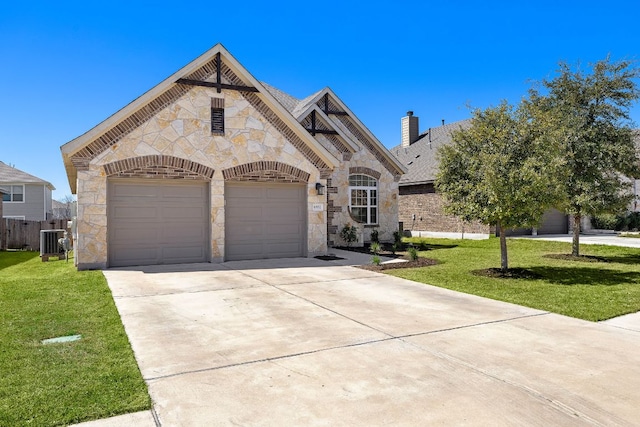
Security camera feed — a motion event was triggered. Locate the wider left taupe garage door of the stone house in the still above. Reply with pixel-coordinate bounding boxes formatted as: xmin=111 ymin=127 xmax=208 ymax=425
xmin=107 ymin=180 xmax=209 ymax=267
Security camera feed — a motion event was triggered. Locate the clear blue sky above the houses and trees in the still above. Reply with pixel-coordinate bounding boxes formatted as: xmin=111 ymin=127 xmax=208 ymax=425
xmin=0 ymin=0 xmax=640 ymax=199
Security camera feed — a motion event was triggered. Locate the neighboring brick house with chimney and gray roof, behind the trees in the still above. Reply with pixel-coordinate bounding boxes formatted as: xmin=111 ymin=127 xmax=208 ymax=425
xmin=390 ymin=111 xmax=568 ymax=237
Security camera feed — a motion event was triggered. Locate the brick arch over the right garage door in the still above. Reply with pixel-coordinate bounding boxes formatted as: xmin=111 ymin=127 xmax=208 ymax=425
xmin=222 ymin=161 xmax=311 ymax=184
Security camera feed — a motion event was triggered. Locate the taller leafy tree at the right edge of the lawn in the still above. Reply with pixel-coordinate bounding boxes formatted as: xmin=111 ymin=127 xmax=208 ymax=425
xmin=530 ymin=57 xmax=640 ymax=256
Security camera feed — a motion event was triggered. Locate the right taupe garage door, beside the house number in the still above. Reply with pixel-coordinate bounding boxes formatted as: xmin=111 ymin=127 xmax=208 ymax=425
xmin=225 ymin=183 xmax=307 ymax=261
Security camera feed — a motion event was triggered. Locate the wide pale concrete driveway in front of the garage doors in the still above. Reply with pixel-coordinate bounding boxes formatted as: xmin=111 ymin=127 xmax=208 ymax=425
xmin=100 ymin=254 xmax=640 ymax=426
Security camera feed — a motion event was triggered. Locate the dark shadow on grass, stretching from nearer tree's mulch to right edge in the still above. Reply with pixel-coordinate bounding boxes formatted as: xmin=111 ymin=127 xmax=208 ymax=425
xmin=528 ymin=267 xmax=640 ymax=286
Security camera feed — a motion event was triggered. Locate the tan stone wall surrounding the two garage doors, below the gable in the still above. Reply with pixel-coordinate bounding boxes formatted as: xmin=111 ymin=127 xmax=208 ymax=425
xmin=76 ymin=87 xmax=327 ymax=269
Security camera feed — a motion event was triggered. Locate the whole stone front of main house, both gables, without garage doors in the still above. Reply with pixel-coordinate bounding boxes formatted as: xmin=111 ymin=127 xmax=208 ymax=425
xmin=62 ymin=45 xmax=404 ymax=268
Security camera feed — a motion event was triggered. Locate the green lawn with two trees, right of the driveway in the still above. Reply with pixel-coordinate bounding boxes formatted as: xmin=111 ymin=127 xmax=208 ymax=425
xmin=385 ymin=238 xmax=640 ymax=321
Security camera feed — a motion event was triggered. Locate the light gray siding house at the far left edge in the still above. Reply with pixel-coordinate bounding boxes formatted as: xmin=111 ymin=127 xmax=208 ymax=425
xmin=0 ymin=161 xmax=55 ymax=221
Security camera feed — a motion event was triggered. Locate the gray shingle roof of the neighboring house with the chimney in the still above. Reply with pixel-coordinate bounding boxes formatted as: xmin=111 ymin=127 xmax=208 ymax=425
xmin=389 ymin=119 xmax=471 ymax=185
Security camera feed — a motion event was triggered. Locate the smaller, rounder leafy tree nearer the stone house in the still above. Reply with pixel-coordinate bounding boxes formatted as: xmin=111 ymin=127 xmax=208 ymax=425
xmin=436 ymin=102 xmax=558 ymax=271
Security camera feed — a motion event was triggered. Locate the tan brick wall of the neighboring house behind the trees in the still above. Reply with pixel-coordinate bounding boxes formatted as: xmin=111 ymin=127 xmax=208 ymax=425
xmin=398 ymin=184 xmax=489 ymax=234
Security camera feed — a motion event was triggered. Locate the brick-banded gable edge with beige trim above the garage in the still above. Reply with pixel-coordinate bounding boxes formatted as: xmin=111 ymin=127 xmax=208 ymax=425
xmin=60 ymin=44 xmax=339 ymax=193
